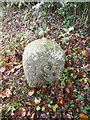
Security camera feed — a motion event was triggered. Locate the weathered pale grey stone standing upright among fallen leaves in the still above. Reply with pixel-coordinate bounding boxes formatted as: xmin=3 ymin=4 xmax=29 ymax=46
xmin=23 ymin=38 xmax=65 ymax=87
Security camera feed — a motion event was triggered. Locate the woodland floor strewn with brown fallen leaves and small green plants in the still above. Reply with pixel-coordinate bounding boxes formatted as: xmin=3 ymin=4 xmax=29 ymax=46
xmin=0 ymin=6 xmax=90 ymax=120
